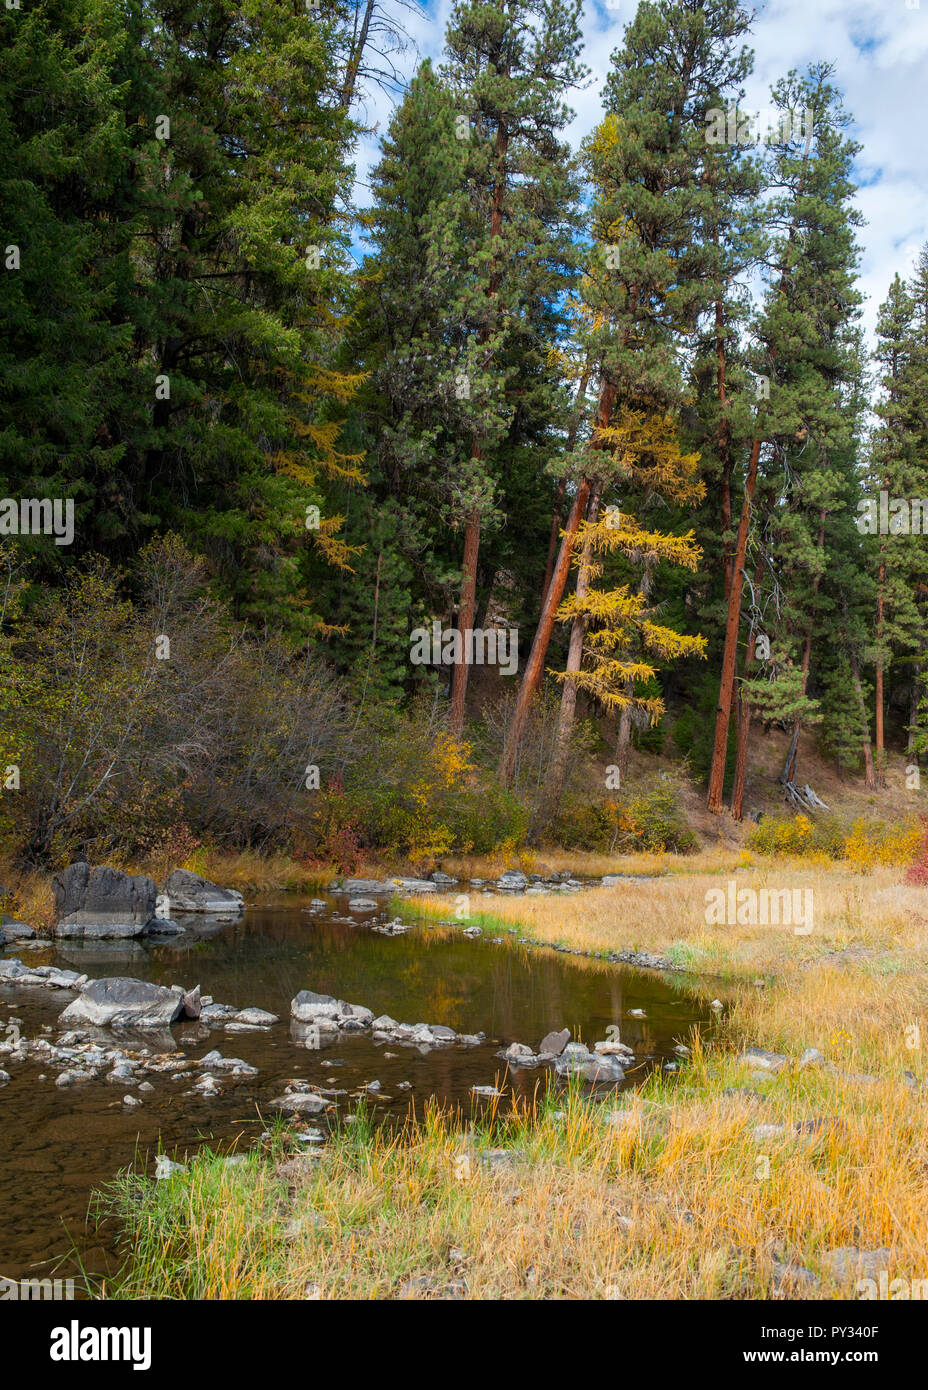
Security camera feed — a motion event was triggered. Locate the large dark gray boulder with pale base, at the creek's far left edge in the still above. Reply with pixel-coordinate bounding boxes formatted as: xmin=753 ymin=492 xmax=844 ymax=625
xmin=51 ymin=863 xmax=157 ymax=940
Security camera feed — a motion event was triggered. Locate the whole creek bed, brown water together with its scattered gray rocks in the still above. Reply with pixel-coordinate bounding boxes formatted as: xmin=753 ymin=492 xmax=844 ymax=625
xmin=0 ymin=884 xmax=711 ymax=1276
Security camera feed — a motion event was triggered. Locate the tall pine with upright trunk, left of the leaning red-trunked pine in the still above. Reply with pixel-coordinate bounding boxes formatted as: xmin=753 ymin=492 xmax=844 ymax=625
xmin=431 ymin=0 xmax=583 ymax=737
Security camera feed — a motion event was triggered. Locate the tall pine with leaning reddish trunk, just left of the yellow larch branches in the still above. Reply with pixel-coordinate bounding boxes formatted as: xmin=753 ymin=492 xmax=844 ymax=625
xmin=500 ymin=0 xmax=749 ymax=784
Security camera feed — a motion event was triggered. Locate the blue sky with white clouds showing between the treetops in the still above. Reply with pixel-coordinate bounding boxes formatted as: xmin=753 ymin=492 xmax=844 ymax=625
xmin=351 ymin=0 xmax=928 ymax=347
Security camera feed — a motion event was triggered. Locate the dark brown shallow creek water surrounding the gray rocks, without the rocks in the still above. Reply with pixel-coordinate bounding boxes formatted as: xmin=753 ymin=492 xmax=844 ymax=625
xmin=0 ymin=895 xmax=711 ymax=1279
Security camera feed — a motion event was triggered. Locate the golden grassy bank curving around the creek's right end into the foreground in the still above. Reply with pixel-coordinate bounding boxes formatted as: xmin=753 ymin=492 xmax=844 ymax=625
xmin=92 ymin=863 xmax=928 ymax=1298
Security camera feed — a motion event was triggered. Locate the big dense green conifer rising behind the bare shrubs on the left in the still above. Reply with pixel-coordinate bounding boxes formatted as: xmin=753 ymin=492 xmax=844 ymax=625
xmin=113 ymin=0 xmax=363 ymax=635
